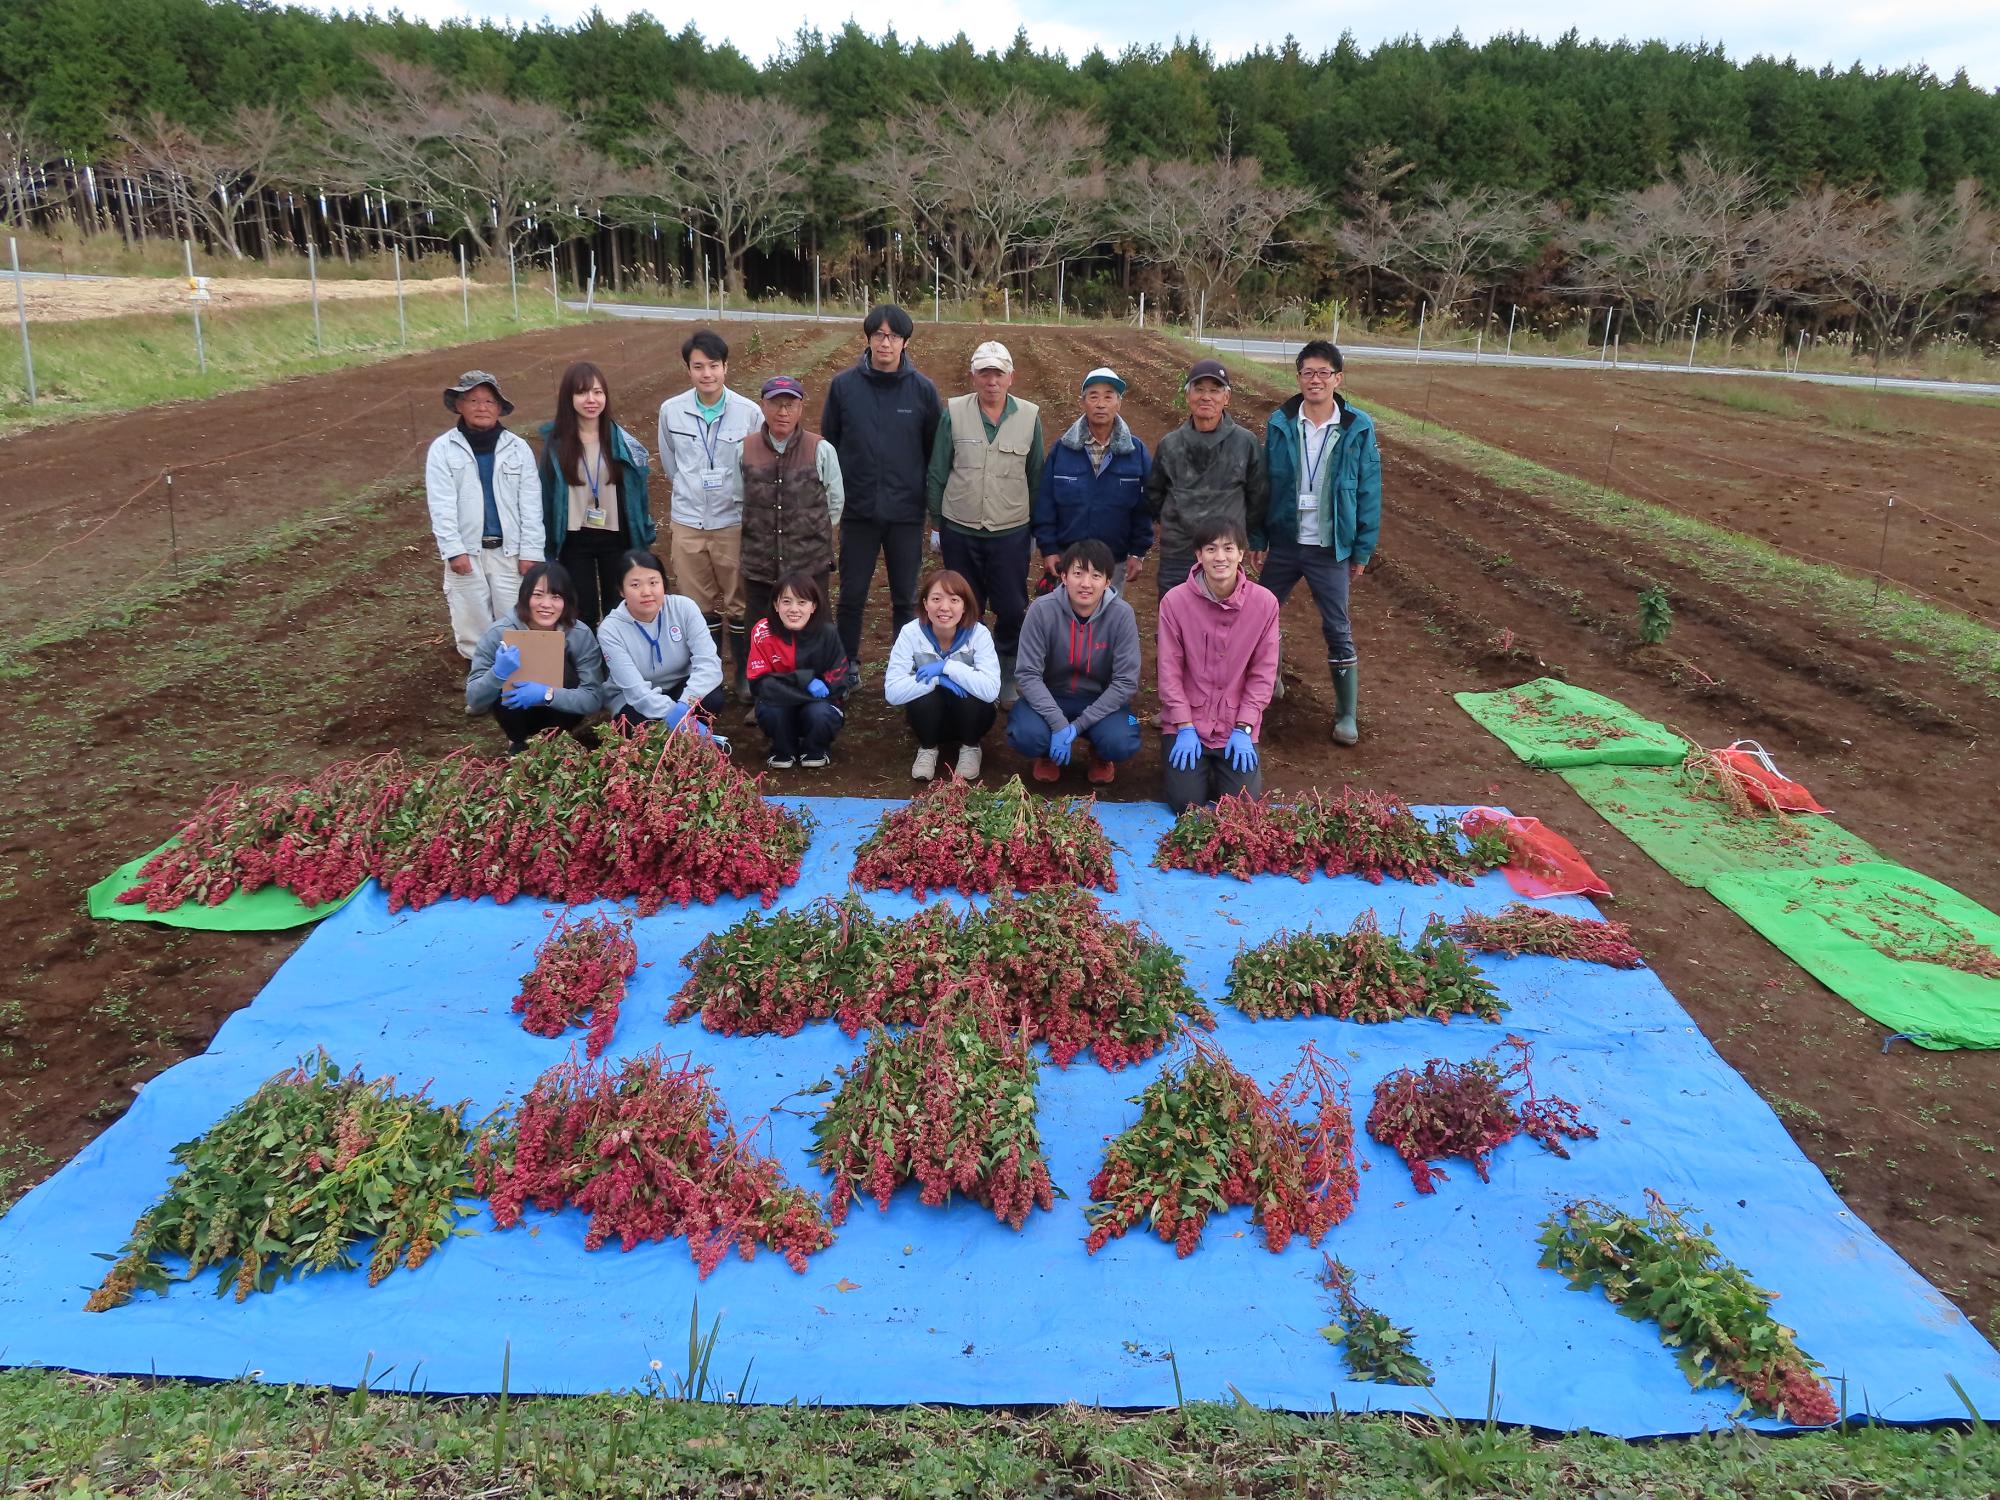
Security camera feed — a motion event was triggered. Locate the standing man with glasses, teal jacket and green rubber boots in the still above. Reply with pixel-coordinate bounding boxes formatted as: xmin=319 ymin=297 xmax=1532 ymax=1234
xmin=1258 ymin=338 xmax=1382 ymax=744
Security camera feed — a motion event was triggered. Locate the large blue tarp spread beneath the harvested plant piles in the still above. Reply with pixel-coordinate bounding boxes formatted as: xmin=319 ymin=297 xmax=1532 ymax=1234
xmin=0 ymin=800 xmax=2000 ymax=1436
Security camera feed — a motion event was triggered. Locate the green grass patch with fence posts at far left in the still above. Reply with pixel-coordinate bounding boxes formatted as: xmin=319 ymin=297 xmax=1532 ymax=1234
xmin=0 ymin=288 xmax=582 ymax=436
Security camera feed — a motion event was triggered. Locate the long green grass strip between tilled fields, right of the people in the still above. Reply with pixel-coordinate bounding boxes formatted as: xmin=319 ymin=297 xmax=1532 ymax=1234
xmin=1368 ymin=402 xmax=2000 ymax=698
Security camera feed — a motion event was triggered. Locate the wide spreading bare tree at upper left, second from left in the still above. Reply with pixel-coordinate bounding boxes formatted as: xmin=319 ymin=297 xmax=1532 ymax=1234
xmin=320 ymin=58 xmax=616 ymax=254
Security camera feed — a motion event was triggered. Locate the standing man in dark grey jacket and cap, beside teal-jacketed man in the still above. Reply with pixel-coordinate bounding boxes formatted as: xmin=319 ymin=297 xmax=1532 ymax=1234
xmin=1146 ymin=360 xmax=1270 ymax=598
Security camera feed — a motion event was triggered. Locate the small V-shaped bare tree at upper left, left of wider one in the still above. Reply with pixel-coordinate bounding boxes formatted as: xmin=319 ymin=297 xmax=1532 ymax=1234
xmin=112 ymin=104 xmax=292 ymax=260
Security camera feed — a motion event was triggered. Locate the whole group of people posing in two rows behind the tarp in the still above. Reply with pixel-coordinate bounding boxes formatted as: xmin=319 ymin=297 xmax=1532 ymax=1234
xmin=426 ymin=306 xmax=1382 ymax=810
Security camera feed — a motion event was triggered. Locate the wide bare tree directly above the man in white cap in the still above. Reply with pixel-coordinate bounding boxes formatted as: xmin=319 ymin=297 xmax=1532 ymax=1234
xmin=848 ymin=90 xmax=1104 ymax=290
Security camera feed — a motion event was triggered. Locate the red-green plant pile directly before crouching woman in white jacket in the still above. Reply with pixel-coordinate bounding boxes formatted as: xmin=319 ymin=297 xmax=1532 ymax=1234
xmin=852 ymin=776 xmax=1118 ymax=900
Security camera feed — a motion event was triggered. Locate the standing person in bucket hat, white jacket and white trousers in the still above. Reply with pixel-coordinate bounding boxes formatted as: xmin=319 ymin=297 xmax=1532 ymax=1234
xmin=424 ymin=370 xmax=542 ymax=660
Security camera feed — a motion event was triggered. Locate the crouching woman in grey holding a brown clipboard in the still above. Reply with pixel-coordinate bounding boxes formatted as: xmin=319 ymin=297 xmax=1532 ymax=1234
xmin=466 ymin=562 xmax=604 ymax=754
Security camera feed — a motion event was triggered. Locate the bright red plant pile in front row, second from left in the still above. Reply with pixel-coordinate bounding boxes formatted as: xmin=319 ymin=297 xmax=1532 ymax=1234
xmin=472 ymin=1048 xmax=834 ymax=1278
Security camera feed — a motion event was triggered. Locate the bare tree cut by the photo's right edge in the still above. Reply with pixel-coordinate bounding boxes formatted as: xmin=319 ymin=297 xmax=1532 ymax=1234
xmin=1828 ymin=182 xmax=1996 ymax=360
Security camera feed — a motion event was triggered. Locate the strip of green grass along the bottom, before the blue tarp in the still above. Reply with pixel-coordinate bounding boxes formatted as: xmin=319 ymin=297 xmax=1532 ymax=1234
xmin=0 ymin=1370 xmax=2000 ymax=1500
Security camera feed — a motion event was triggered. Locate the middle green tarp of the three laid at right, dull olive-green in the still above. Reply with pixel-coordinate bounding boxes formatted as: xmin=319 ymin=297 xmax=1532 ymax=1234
xmin=1562 ymin=766 xmax=1882 ymax=886
